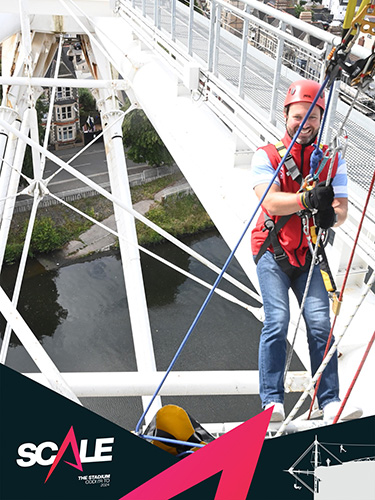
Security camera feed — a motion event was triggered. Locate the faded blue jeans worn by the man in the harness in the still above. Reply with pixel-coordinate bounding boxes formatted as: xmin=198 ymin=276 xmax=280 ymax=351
xmin=257 ymin=251 xmax=339 ymax=408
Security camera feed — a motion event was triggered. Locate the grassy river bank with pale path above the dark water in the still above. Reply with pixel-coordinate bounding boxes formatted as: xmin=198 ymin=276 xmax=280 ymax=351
xmin=6 ymin=175 xmax=213 ymax=269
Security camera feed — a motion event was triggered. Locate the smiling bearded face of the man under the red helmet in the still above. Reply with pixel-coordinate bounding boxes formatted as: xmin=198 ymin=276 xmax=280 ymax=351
xmin=284 ymin=102 xmax=321 ymax=144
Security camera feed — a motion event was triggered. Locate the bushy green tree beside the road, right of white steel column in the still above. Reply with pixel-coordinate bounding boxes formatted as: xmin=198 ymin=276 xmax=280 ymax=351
xmin=123 ymin=98 xmax=174 ymax=166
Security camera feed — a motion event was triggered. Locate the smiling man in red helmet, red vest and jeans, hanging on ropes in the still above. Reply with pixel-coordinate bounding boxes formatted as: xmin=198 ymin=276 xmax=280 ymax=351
xmin=251 ymin=80 xmax=362 ymax=421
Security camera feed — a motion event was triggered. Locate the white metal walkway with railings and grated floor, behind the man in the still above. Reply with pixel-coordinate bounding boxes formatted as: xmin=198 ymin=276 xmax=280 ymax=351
xmin=116 ymin=0 xmax=375 ymax=190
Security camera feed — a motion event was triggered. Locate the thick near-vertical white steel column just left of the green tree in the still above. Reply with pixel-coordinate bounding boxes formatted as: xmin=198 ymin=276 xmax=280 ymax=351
xmin=98 ymin=91 xmax=161 ymax=419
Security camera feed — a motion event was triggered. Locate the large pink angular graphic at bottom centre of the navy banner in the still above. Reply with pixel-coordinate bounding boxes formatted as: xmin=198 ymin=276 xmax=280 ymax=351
xmin=120 ymin=408 xmax=272 ymax=500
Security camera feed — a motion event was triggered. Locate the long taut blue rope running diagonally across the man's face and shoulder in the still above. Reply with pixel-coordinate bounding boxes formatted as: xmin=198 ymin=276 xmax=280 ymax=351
xmin=135 ymin=76 xmax=329 ymax=434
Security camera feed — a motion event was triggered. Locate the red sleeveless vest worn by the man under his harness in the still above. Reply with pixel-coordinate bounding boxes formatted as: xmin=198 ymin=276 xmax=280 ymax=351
xmin=251 ymin=133 xmax=338 ymax=267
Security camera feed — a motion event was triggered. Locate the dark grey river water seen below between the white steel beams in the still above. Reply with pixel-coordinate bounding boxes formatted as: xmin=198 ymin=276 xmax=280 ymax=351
xmin=0 ymin=231 xmax=302 ymax=429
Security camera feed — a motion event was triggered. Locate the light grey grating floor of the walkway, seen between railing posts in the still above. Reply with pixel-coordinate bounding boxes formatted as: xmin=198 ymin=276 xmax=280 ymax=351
xmin=127 ymin=0 xmax=375 ymax=197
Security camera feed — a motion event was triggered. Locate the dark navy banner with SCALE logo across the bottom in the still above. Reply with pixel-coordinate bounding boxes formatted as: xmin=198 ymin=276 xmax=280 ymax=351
xmin=0 ymin=365 xmax=375 ymax=500
